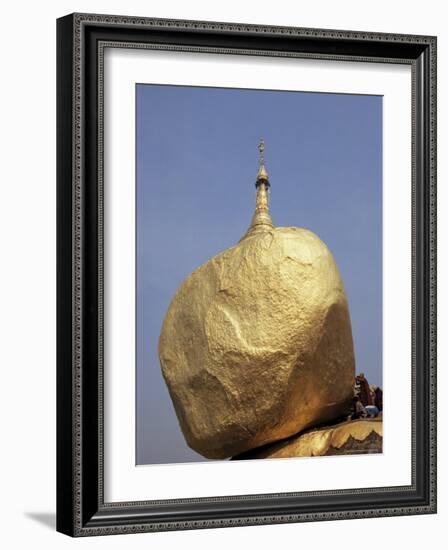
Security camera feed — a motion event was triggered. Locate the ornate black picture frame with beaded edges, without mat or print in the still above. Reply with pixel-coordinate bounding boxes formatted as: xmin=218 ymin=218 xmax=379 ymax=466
xmin=57 ymin=14 xmax=436 ymax=536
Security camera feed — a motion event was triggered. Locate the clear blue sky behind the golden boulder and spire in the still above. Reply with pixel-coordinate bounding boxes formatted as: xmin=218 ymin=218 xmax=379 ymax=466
xmin=136 ymin=84 xmax=382 ymax=464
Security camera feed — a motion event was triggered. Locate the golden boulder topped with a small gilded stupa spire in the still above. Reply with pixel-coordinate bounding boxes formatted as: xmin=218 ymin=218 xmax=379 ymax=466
xmin=159 ymin=141 xmax=355 ymax=459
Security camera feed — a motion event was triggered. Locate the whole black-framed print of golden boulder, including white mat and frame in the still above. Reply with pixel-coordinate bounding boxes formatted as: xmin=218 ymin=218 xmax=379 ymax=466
xmin=57 ymin=14 xmax=436 ymax=536
